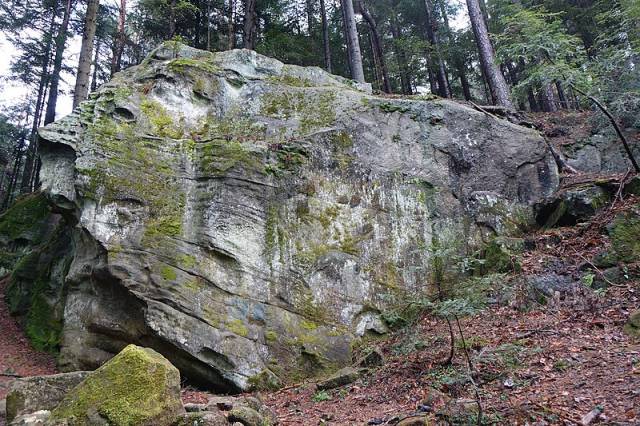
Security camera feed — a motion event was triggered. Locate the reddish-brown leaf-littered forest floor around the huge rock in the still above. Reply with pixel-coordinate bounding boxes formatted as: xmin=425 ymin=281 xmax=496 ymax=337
xmin=0 ymin=111 xmax=640 ymax=425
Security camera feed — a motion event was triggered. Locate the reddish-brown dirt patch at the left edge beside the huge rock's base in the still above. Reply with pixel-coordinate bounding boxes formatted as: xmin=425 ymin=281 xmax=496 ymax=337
xmin=0 ymin=277 xmax=57 ymax=399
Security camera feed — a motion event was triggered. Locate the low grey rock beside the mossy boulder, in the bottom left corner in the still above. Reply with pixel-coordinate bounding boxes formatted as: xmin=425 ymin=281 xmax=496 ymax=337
xmin=6 ymin=371 xmax=89 ymax=423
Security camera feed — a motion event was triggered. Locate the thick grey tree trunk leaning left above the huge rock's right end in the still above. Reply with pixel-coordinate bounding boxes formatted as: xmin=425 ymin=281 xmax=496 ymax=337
xmin=466 ymin=0 xmax=513 ymax=108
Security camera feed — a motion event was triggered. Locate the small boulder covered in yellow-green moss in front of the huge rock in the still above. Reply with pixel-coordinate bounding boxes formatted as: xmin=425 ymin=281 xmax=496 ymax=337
xmin=51 ymin=345 xmax=184 ymax=426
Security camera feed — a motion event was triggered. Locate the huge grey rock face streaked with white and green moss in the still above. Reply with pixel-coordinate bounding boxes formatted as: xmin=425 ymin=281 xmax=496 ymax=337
xmin=25 ymin=43 xmax=558 ymax=392
